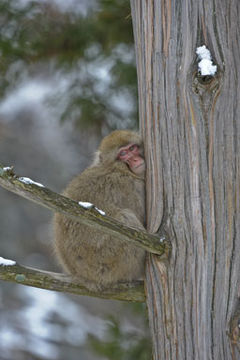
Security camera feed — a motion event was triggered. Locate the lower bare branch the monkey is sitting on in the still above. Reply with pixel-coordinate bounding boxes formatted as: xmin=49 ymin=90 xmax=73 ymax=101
xmin=0 ymin=264 xmax=145 ymax=302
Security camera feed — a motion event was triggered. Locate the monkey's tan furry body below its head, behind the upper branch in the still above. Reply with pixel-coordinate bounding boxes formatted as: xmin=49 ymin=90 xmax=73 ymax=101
xmin=55 ymin=164 xmax=145 ymax=289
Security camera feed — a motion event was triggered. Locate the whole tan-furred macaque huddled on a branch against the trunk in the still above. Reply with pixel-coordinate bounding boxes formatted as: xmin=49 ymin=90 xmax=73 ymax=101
xmin=55 ymin=130 xmax=145 ymax=291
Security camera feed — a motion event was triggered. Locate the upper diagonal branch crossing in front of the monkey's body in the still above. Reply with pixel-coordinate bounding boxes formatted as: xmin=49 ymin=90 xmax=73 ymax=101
xmin=0 ymin=166 xmax=170 ymax=255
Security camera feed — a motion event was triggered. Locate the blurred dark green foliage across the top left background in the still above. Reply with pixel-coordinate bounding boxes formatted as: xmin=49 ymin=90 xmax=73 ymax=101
xmin=0 ymin=0 xmax=137 ymax=128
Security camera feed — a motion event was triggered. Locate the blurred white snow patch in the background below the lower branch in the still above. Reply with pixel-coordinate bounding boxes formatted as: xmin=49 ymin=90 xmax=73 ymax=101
xmin=0 ymin=287 xmax=108 ymax=360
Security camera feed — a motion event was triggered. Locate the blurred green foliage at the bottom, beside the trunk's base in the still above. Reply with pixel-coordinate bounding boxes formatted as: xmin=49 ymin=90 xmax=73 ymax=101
xmin=89 ymin=317 xmax=151 ymax=360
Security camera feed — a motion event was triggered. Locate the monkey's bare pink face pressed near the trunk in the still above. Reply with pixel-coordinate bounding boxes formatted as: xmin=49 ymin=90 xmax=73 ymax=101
xmin=117 ymin=144 xmax=145 ymax=175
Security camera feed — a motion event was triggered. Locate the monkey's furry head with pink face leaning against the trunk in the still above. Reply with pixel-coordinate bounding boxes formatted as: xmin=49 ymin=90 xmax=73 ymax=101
xmin=95 ymin=130 xmax=145 ymax=175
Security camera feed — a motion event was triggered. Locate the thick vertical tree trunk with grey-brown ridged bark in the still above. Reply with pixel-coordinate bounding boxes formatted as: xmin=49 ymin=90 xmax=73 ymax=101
xmin=131 ymin=0 xmax=240 ymax=360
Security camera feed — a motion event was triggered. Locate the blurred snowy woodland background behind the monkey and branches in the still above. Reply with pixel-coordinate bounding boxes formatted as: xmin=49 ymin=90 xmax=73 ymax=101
xmin=0 ymin=0 xmax=150 ymax=360
